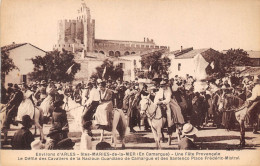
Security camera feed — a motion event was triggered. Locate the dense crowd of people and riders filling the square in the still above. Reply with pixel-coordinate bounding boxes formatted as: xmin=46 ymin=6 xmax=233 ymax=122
xmin=1 ymin=72 xmax=260 ymax=149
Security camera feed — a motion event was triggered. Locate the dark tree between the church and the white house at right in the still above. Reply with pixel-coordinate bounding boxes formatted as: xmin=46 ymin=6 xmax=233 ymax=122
xmin=141 ymin=50 xmax=171 ymax=78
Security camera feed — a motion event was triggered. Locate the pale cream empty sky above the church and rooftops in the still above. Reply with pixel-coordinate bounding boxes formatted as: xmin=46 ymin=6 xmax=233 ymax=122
xmin=1 ymin=0 xmax=260 ymax=51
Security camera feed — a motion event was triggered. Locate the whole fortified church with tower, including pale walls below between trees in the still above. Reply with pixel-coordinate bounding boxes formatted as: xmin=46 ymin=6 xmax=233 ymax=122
xmin=53 ymin=1 xmax=169 ymax=82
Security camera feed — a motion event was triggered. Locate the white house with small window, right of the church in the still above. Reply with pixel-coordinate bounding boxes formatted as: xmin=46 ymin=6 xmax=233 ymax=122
xmin=168 ymin=48 xmax=217 ymax=80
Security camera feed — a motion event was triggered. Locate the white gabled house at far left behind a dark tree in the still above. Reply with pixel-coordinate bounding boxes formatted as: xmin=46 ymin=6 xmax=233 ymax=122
xmin=1 ymin=43 xmax=46 ymax=85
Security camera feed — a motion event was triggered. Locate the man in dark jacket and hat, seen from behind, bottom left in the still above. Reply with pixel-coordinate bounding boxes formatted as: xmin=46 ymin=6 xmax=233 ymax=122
xmin=11 ymin=115 xmax=34 ymax=150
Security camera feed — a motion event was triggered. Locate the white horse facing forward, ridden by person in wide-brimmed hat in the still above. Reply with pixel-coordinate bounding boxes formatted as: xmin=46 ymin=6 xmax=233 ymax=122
xmin=140 ymin=95 xmax=180 ymax=149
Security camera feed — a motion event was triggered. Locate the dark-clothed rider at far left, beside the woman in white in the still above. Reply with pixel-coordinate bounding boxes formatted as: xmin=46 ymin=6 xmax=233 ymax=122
xmin=2 ymin=84 xmax=23 ymax=131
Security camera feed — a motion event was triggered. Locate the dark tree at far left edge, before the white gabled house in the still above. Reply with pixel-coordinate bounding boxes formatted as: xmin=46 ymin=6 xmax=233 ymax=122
xmin=1 ymin=51 xmax=19 ymax=83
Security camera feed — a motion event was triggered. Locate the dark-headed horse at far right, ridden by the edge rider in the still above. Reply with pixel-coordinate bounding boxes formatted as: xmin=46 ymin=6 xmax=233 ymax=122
xmin=218 ymin=94 xmax=257 ymax=147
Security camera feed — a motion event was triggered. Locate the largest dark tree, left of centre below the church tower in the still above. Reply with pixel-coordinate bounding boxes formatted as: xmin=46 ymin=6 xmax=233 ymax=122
xmin=29 ymin=50 xmax=80 ymax=82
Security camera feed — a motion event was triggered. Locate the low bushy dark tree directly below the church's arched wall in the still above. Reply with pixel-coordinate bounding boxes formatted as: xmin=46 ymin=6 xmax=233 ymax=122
xmin=91 ymin=59 xmax=124 ymax=80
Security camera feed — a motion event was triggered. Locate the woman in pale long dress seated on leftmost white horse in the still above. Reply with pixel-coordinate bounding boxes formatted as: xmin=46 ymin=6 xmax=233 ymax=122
xmin=17 ymin=85 xmax=34 ymax=121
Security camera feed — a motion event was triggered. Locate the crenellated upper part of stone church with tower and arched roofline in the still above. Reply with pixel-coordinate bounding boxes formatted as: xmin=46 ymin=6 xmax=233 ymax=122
xmin=54 ymin=2 xmax=169 ymax=57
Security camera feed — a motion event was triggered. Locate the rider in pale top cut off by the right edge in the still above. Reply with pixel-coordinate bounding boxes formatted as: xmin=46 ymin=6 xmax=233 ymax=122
xmin=246 ymin=78 xmax=260 ymax=134
